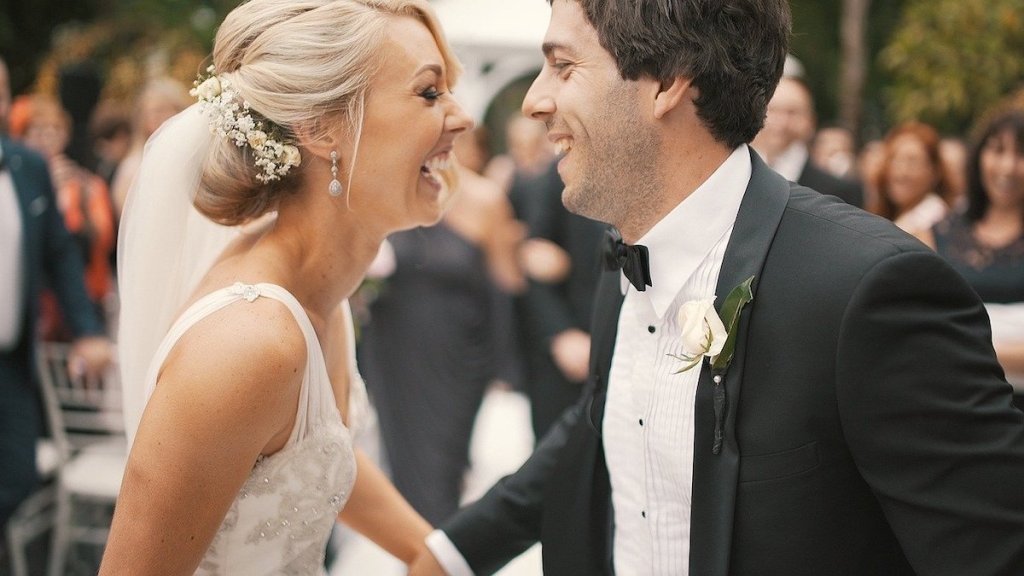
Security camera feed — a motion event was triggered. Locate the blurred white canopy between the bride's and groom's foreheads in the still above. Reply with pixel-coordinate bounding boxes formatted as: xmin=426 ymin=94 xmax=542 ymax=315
xmin=431 ymin=0 xmax=551 ymax=122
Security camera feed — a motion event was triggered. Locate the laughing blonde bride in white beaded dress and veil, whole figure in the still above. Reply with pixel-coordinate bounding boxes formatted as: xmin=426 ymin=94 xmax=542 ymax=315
xmin=100 ymin=0 xmax=472 ymax=576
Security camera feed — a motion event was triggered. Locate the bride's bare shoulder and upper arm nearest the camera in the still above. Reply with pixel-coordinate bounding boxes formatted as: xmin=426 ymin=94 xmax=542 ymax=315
xmin=100 ymin=298 xmax=306 ymax=576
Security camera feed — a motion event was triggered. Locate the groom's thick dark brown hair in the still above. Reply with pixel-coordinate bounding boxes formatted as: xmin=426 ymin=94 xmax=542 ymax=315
xmin=548 ymin=0 xmax=792 ymax=148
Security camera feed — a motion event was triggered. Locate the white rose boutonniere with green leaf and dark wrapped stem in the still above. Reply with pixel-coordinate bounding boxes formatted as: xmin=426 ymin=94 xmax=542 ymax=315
xmin=669 ymin=276 xmax=754 ymax=454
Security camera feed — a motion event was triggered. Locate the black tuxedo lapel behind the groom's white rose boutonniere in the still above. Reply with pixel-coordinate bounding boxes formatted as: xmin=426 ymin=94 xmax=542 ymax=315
xmin=690 ymin=151 xmax=790 ymax=576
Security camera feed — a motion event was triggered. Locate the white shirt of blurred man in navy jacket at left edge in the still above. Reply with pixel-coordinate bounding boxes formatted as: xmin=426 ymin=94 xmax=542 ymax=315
xmin=0 ymin=143 xmax=24 ymax=352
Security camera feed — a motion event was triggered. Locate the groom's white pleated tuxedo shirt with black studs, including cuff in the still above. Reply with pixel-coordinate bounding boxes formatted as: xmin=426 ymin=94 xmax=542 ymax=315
xmin=427 ymin=145 xmax=751 ymax=576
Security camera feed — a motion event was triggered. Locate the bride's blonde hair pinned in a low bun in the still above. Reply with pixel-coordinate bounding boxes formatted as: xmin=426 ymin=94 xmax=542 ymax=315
xmin=195 ymin=0 xmax=462 ymax=225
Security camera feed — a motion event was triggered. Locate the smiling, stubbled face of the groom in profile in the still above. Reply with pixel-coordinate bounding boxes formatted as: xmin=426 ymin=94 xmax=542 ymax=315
xmin=522 ymin=0 xmax=657 ymax=225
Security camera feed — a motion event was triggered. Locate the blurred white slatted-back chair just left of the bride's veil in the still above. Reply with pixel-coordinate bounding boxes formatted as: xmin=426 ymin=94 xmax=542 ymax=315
xmin=30 ymin=342 xmax=127 ymax=576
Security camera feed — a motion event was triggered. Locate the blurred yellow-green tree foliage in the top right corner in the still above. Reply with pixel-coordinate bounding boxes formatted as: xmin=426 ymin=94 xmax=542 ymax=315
xmin=880 ymin=0 xmax=1024 ymax=133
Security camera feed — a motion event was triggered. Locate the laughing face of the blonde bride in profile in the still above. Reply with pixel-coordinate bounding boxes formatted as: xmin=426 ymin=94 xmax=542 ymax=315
xmin=350 ymin=17 xmax=473 ymax=230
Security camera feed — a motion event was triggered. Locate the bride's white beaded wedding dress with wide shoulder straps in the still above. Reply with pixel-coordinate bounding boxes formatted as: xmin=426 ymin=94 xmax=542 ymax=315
xmin=145 ymin=283 xmax=362 ymax=576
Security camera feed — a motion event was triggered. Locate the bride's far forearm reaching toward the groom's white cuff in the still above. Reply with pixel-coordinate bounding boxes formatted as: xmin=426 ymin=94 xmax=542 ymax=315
xmin=339 ymin=450 xmax=431 ymax=564
